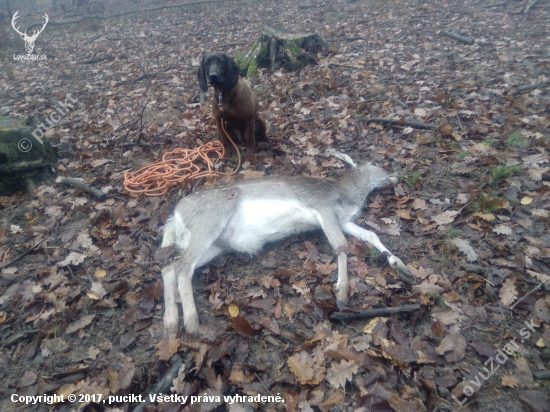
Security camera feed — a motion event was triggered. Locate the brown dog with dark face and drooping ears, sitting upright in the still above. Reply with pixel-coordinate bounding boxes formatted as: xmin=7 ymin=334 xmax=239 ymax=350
xmin=198 ymin=53 xmax=266 ymax=160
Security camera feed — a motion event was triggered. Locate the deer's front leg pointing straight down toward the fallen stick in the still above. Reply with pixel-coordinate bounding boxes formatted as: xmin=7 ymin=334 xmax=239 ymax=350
xmin=320 ymin=213 xmax=349 ymax=309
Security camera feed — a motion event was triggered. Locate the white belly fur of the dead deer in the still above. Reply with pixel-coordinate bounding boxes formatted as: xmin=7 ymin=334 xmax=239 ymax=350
xmin=220 ymin=199 xmax=321 ymax=253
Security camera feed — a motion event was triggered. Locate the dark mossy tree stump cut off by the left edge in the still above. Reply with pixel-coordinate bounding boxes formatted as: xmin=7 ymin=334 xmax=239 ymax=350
xmin=0 ymin=116 xmax=56 ymax=196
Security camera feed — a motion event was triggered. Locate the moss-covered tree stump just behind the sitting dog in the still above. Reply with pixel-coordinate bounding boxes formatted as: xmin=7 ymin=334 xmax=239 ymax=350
xmin=236 ymin=26 xmax=326 ymax=77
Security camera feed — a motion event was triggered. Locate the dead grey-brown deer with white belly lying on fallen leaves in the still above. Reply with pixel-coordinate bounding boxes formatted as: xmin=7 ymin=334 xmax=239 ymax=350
xmin=162 ymin=152 xmax=414 ymax=334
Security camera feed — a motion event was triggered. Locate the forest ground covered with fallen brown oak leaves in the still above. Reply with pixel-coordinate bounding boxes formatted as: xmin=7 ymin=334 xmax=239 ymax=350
xmin=0 ymin=0 xmax=550 ymax=412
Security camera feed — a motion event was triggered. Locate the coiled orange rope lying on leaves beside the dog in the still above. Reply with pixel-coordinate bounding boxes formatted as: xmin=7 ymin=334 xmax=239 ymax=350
xmin=124 ymin=120 xmax=241 ymax=196
